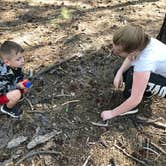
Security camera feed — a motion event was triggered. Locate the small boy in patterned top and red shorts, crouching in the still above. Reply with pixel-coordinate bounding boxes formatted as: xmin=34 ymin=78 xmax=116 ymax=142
xmin=0 ymin=41 xmax=28 ymax=118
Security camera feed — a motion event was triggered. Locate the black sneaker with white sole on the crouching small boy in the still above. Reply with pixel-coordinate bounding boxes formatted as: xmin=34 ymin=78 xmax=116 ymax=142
xmin=0 ymin=105 xmax=22 ymax=118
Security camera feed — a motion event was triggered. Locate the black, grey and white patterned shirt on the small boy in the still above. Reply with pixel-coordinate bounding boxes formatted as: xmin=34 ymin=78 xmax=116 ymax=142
xmin=0 ymin=61 xmax=24 ymax=95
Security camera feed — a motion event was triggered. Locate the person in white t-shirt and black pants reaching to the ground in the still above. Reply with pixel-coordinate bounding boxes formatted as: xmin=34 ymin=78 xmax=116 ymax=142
xmin=101 ymin=25 xmax=166 ymax=120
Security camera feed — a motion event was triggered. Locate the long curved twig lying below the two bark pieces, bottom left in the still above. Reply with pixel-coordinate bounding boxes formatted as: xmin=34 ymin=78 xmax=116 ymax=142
xmin=15 ymin=151 xmax=61 ymax=166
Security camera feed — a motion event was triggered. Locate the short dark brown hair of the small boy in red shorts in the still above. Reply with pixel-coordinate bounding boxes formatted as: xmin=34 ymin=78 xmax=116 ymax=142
xmin=0 ymin=41 xmax=24 ymax=58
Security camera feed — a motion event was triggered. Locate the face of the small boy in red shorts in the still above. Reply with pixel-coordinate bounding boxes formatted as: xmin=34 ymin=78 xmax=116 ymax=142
xmin=4 ymin=51 xmax=24 ymax=68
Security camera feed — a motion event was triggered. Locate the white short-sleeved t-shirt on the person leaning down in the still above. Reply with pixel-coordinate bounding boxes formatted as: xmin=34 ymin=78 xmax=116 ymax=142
xmin=132 ymin=38 xmax=166 ymax=77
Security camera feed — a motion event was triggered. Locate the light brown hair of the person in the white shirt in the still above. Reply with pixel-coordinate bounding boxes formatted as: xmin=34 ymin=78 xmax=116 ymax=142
xmin=113 ymin=25 xmax=149 ymax=53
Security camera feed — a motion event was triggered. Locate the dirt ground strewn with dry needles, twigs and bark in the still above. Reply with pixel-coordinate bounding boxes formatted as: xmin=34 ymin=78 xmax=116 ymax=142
xmin=0 ymin=0 xmax=166 ymax=166
